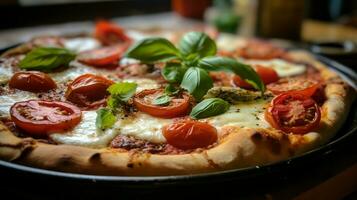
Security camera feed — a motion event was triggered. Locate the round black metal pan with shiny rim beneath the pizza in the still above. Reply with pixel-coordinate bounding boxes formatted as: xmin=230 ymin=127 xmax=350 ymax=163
xmin=0 ymin=48 xmax=357 ymax=192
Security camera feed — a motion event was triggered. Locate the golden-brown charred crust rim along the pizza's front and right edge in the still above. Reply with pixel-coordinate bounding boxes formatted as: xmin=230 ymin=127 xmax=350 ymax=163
xmin=0 ymin=51 xmax=355 ymax=176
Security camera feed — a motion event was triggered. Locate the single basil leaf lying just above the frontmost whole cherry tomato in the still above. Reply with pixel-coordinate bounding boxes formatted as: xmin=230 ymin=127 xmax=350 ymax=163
xmin=190 ymin=98 xmax=230 ymax=119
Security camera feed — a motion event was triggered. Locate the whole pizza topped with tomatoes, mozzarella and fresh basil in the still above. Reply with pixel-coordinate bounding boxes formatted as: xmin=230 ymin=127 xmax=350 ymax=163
xmin=0 ymin=21 xmax=355 ymax=176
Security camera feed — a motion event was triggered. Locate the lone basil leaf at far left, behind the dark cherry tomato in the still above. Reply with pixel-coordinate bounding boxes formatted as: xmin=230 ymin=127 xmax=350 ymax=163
xmin=19 ymin=47 xmax=76 ymax=70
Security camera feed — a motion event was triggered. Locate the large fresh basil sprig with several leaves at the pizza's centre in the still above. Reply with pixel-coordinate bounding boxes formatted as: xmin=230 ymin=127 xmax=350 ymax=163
xmin=126 ymin=32 xmax=265 ymax=101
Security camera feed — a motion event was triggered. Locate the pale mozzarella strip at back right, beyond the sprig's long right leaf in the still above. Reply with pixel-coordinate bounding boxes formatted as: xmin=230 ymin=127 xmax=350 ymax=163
xmin=243 ymin=59 xmax=306 ymax=77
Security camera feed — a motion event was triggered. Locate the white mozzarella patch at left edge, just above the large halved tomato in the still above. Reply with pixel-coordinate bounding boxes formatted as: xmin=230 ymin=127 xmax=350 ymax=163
xmin=0 ymin=90 xmax=37 ymax=117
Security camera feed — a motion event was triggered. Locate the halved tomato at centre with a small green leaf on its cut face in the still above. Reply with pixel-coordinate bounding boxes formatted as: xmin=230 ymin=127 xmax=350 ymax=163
xmin=134 ymin=89 xmax=190 ymax=118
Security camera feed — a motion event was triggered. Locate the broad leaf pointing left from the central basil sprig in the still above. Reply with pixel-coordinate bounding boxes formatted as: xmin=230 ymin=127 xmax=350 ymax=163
xmin=125 ymin=38 xmax=179 ymax=63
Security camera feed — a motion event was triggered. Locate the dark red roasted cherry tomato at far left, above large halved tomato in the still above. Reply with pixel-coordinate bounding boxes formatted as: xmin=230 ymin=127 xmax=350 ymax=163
xmin=9 ymin=71 xmax=57 ymax=92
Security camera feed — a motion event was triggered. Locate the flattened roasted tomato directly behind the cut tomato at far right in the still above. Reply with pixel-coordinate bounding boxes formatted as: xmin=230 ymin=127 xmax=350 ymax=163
xmin=267 ymin=77 xmax=320 ymax=97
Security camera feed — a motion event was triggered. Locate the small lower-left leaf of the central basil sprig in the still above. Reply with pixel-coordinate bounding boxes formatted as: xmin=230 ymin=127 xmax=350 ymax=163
xmin=161 ymin=63 xmax=186 ymax=83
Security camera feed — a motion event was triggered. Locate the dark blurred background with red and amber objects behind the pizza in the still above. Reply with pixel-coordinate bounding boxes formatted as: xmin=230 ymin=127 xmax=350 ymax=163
xmin=0 ymin=0 xmax=357 ymax=68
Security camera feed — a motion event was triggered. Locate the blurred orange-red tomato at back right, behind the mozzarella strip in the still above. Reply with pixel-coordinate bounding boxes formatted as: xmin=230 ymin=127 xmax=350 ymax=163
xmin=238 ymin=40 xmax=287 ymax=60
